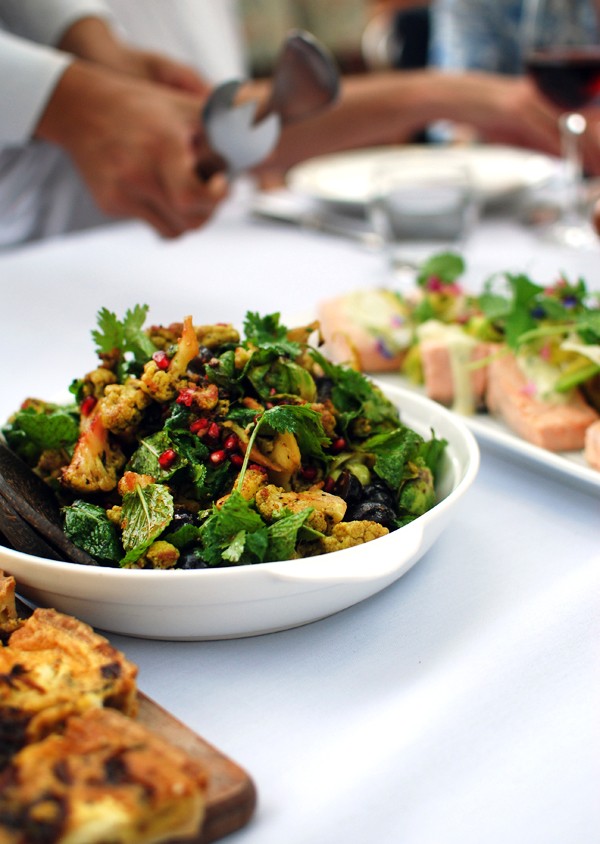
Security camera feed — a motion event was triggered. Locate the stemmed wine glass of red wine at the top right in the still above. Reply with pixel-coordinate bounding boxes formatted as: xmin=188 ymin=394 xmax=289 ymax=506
xmin=522 ymin=0 xmax=600 ymax=248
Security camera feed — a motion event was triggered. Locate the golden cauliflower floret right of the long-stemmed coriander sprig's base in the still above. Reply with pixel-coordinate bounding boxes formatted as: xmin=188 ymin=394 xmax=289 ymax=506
xmin=255 ymin=484 xmax=346 ymax=533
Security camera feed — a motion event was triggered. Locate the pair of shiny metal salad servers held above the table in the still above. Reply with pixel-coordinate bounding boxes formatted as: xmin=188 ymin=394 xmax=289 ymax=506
xmin=202 ymin=30 xmax=339 ymax=176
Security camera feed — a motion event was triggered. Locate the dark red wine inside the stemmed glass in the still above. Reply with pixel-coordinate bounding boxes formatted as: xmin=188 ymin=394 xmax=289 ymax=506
xmin=526 ymin=47 xmax=600 ymax=112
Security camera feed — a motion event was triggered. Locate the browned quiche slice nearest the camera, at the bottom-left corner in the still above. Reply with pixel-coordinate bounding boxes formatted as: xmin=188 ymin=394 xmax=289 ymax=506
xmin=0 ymin=709 xmax=207 ymax=844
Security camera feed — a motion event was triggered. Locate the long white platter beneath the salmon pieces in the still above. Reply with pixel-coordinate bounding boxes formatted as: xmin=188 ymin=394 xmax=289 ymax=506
xmin=372 ymin=374 xmax=600 ymax=494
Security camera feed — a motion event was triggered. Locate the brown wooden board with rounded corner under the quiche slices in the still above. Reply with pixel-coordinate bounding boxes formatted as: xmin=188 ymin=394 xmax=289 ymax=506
xmin=137 ymin=692 xmax=256 ymax=844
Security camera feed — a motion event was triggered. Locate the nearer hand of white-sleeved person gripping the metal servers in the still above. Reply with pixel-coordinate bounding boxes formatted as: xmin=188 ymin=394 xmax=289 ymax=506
xmin=35 ymin=61 xmax=227 ymax=237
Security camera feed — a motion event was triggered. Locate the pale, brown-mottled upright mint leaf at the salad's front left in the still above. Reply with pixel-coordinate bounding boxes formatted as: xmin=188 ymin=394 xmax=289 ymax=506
xmin=120 ymin=484 xmax=174 ymax=566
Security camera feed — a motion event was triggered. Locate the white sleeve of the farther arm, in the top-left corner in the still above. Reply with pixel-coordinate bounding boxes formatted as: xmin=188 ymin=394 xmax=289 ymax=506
xmin=0 ymin=0 xmax=110 ymax=45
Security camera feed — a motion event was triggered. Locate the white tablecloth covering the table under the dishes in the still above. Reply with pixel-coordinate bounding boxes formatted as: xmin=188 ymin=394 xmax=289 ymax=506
xmin=0 ymin=186 xmax=600 ymax=844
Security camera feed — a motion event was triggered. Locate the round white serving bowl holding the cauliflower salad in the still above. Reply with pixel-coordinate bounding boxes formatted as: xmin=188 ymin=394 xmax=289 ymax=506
xmin=0 ymin=386 xmax=479 ymax=640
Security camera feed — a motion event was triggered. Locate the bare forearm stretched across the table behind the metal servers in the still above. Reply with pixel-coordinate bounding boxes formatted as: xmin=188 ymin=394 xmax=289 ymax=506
xmin=253 ymin=69 xmax=600 ymax=183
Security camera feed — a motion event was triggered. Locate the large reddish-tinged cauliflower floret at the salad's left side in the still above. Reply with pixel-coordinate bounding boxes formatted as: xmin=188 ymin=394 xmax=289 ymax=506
xmin=60 ymin=406 xmax=125 ymax=493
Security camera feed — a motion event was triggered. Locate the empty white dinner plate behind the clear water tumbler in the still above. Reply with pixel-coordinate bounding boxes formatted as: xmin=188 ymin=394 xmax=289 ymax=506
xmin=287 ymin=145 xmax=558 ymax=212
